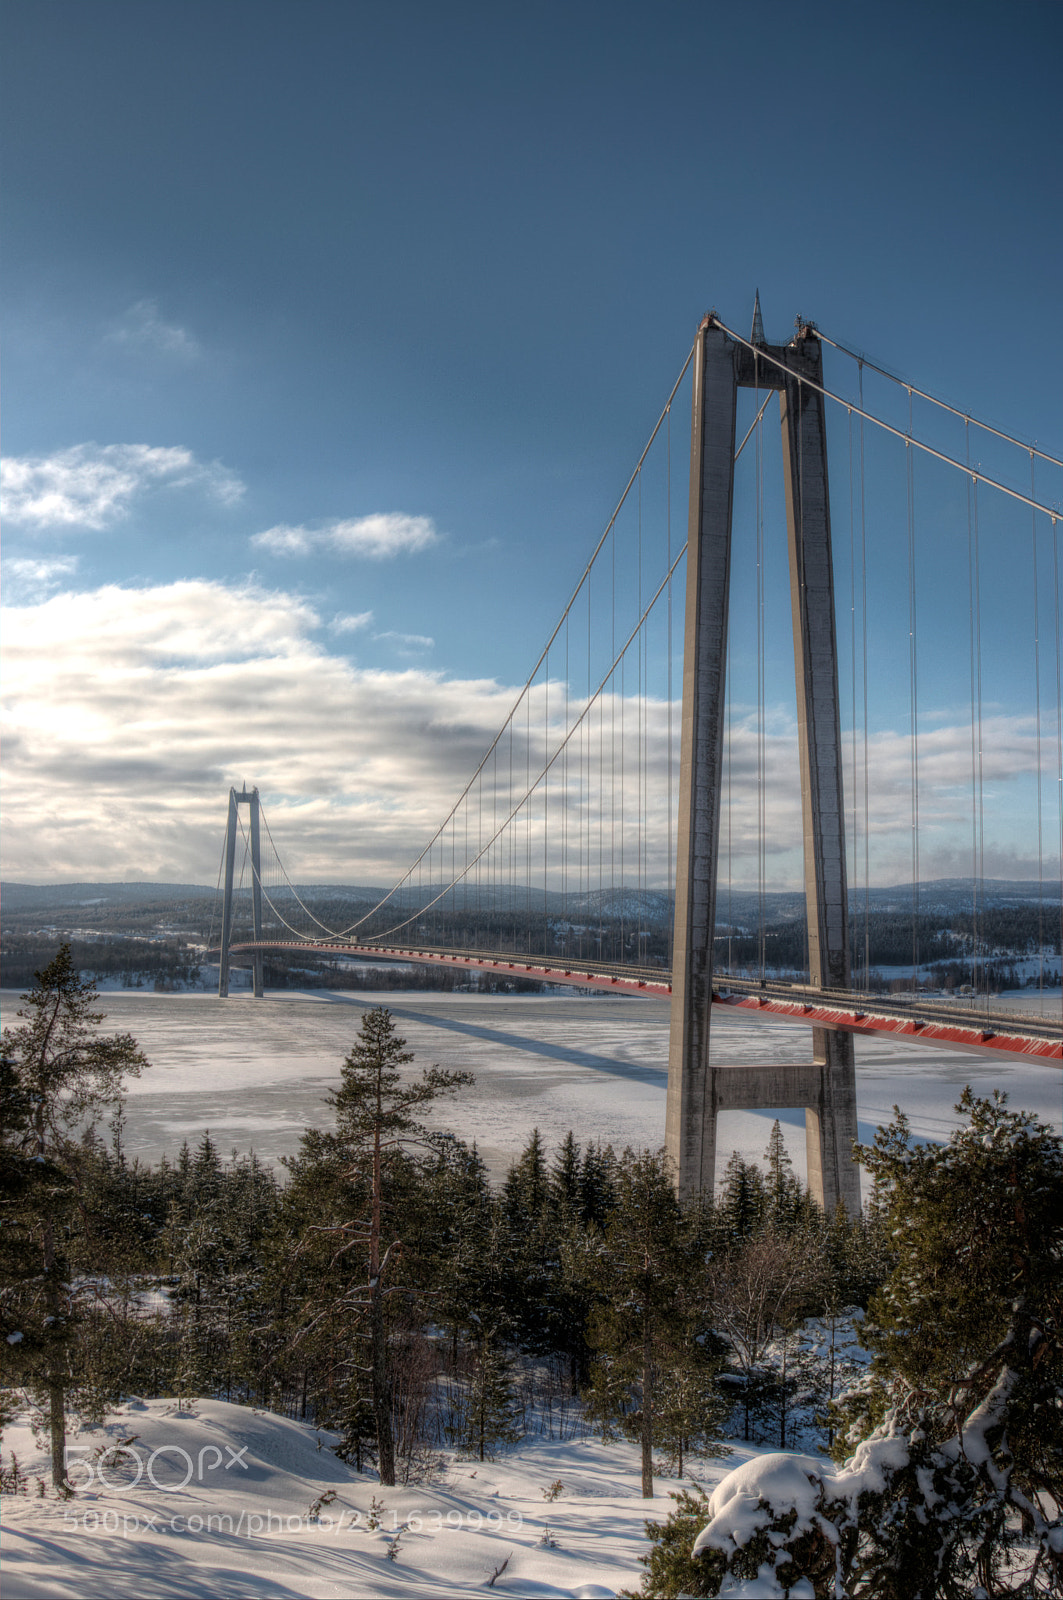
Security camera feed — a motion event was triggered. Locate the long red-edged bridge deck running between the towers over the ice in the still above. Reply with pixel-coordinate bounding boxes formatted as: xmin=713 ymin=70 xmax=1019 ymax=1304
xmin=219 ymin=939 xmax=1063 ymax=1061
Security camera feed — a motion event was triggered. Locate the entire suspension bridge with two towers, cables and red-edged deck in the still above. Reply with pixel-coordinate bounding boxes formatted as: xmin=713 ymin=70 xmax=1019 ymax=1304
xmin=211 ymin=296 xmax=1063 ymax=1208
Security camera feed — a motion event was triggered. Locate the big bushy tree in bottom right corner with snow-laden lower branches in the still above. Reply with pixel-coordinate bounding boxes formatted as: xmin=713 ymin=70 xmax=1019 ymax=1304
xmin=644 ymin=1091 xmax=1063 ymax=1600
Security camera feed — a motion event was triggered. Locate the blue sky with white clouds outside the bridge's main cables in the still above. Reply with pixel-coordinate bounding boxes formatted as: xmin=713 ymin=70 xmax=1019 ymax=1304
xmin=3 ymin=0 xmax=1063 ymax=882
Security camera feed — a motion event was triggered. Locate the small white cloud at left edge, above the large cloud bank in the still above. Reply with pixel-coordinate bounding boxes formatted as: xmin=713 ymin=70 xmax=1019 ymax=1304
xmin=0 ymin=443 xmax=243 ymax=528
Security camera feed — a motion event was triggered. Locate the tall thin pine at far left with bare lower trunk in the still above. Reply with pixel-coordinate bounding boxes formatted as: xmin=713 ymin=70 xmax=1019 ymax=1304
xmin=2 ymin=944 xmax=147 ymax=1493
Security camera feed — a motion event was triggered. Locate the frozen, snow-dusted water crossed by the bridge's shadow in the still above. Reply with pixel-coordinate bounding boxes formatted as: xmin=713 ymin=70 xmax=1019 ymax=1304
xmin=2 ymin=990 xmax=1063 ymax=1196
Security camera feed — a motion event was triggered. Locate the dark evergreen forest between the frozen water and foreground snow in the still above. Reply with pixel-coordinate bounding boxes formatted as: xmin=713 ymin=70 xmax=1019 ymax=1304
xmin=0 ymin=947 xmax=1063 ymax=1600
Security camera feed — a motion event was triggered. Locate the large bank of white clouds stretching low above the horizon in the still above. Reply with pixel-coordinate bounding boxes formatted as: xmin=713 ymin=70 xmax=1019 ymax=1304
xmin=2 ymin=582 xmax=1058 ymax=893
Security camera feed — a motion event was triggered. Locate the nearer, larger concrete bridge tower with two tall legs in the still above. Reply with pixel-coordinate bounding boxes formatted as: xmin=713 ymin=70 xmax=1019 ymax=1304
xmin=666 ymin=301 xmax=860 ymax=1213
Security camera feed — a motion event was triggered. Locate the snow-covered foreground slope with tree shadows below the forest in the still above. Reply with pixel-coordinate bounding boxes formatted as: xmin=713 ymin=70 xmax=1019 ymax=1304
xmin=3 ymin=1400 xmax=762 ymax=1600
